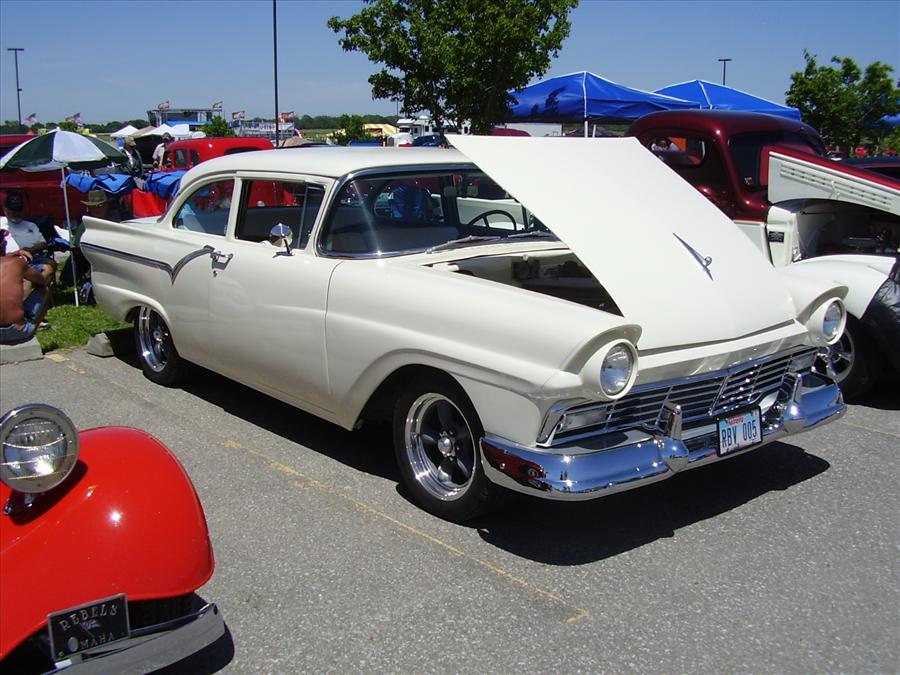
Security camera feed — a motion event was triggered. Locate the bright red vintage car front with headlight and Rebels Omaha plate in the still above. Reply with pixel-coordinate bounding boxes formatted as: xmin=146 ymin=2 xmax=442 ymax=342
xmin=0 ymin=404 xmax=225 ymax=672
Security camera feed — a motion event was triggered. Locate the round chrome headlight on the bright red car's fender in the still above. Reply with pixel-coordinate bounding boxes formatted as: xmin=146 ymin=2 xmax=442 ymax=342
xmin=0 ymin=403 xmax=78 ymax=494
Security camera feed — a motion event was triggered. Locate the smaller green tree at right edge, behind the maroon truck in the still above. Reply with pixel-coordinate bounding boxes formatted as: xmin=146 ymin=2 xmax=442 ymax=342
xmin=786 ymin=50 xmax=900 ymax=147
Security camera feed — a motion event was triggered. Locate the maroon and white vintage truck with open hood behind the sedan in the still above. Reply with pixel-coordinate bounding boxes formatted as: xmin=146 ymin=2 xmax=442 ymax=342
xmin=628 ymin=110 xmax=900 ymax=398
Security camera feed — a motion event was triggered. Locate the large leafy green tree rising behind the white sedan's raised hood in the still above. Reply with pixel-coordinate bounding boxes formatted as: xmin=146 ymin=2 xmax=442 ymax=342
xmin=328 ymin=0 xmax=578 ymax=132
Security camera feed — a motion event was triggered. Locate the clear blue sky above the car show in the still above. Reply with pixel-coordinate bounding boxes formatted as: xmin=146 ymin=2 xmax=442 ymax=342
xmin=0 ymin=0 xmax=900 ymax=122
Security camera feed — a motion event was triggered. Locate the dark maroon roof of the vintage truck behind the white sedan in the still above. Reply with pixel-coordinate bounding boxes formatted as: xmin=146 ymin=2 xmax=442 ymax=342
xmin=628 ymin=110 xmax=819 ymax=138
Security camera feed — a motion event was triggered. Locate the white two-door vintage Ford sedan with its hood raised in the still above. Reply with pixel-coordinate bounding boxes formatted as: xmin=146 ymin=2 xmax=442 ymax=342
xmin=82 ymin=136 xmax=846 ymax=520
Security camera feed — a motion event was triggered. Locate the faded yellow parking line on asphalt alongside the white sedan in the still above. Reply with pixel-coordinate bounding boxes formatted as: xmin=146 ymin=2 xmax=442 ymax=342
xmin=222 ymin=438 xmax=590 ymax=624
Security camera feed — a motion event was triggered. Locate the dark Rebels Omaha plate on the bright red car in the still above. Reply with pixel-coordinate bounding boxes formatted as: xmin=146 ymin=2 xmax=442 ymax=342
xmin=47 ymin=594 xmax=130 ymax=661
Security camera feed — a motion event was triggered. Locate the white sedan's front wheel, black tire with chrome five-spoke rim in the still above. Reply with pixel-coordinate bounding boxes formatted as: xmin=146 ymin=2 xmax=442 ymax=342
xmin=393 ymin=377 xmax=501 ymax=522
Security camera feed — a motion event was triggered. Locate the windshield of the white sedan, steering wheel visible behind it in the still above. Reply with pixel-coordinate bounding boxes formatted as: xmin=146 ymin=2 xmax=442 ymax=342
xmin=319 ymin=169 xmax=553 ymax=256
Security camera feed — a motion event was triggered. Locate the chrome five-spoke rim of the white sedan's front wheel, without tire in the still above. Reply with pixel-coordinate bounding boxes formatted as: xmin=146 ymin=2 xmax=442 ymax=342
xmin=404 ymin=393 xmax=478 ymax=501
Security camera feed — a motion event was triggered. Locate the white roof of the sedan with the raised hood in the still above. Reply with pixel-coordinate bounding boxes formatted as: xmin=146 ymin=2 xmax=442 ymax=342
xmin=182 ymin=147 xmax=471 ymax=185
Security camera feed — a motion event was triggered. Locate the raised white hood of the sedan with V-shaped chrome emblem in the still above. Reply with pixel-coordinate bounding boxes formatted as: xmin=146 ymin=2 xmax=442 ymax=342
xmin=449 ymin=136 xmax=796 ymax=349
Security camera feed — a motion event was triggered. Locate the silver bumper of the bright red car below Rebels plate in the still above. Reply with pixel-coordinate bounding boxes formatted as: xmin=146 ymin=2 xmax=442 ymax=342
xmin=56 ymin=603 xmax=225 ymax=673
